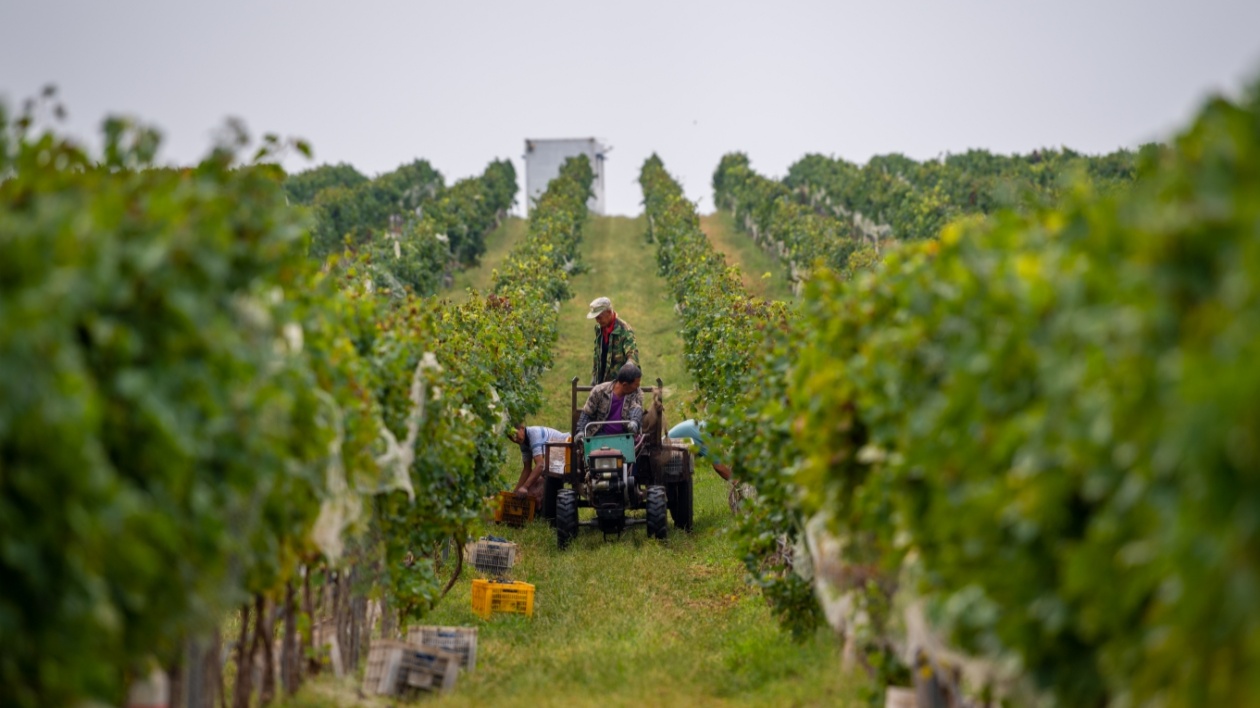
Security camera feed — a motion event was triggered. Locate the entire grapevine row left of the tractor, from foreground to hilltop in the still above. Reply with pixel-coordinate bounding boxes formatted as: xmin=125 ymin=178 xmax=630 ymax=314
xmin=0 ymin=95 xmax=590 ymax=705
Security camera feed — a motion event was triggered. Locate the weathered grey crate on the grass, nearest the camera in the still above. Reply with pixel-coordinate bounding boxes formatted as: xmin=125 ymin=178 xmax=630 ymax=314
xmin=363 ymin=640 xmax=460 ymax=698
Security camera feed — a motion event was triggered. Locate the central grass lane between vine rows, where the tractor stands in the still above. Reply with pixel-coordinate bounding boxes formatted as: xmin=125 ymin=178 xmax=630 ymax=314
xmin=294 ymin=218 xmax=857 ymax=707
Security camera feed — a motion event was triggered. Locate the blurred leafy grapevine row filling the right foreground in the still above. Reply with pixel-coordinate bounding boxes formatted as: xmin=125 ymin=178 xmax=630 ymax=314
xmin=710 ymin=82 xmax=1260 ymax=705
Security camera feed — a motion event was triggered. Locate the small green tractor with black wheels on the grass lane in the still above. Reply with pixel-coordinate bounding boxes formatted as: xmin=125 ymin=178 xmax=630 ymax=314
xmin=542 ymin=378 xmax=694 ymax=549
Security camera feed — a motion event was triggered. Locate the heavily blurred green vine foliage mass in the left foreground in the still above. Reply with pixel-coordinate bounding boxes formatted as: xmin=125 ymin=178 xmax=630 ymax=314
xmin=0 ymin=107 xmax=372 ymax=705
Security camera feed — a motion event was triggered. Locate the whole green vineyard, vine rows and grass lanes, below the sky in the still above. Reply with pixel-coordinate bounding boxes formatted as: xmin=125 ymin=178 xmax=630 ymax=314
xmin=0 ymin=74 xmax=1260 ymax=708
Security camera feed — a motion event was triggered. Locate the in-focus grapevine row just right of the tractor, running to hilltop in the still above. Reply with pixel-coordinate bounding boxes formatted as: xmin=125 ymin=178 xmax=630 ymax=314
xmin=639 ymin=155 xmax=819 ymax=631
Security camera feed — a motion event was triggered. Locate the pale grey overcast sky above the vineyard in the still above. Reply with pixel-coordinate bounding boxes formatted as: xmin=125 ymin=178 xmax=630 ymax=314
xmin=0 ymin=0 xmax=1260 ymax=214
